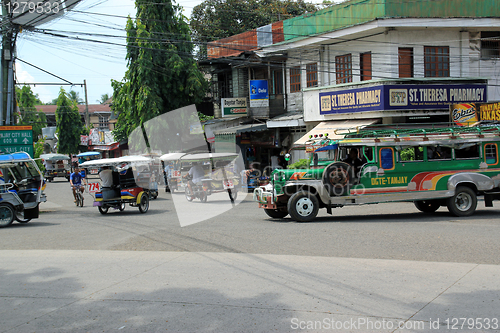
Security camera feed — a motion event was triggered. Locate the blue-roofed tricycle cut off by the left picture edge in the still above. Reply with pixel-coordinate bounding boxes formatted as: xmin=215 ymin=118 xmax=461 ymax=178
xmin=0 ymin=152 xmax=47 ymax=227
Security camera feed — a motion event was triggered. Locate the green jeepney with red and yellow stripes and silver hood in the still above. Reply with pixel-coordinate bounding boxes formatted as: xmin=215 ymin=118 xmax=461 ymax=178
xmin=254 ymin=125 xmax=500 ymax=221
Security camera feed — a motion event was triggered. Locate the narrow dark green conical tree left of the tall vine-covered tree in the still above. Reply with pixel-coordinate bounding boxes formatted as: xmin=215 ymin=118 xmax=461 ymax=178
xmin=56 ymin=88 xmax=83 ymax=154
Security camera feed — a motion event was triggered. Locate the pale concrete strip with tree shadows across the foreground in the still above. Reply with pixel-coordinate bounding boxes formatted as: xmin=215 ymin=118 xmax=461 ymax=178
xmin=0 ymin=250 xmax=500 ymax=332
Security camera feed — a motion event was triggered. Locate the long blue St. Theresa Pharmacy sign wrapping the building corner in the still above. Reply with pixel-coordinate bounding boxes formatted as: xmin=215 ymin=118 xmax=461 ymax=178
xmin=319 ymin=84 xmax=487 ymax=114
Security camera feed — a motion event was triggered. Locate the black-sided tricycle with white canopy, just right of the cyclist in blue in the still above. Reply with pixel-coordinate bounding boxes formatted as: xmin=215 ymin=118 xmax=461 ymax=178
xmin=80 ymin=155 xmax=152 ymax=214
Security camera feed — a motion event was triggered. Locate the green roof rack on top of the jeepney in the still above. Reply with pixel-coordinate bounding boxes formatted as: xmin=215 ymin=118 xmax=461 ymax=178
xmin=345 ymin=122 xmax=500 ymax=140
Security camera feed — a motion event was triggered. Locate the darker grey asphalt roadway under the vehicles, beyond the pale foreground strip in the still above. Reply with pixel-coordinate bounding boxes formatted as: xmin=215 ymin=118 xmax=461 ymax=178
xmin=0 ymin=181 xmax=500 ymax=264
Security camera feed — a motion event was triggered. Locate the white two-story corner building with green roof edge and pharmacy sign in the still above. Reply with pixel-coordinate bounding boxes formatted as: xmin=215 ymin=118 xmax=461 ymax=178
xmin=201 ymin=0 xmax=500 ymax=163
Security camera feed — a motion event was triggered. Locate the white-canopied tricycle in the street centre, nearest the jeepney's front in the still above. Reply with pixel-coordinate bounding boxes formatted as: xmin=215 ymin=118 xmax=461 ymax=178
xmin=179 ymin=153 xmax=241 ymax=202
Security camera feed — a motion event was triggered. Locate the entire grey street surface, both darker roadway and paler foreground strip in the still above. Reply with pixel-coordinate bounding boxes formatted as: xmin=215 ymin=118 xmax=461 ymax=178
xmin=0 ymin=181 xmax=500 ymax=333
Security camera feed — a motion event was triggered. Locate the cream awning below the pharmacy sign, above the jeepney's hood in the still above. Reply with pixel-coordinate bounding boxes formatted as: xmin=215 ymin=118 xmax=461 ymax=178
xmin=295 ymin=119 xmax=378 ymax=145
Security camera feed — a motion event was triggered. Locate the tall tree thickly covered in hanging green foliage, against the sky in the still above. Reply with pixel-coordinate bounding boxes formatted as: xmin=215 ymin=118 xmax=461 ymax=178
xmin=112 ymin=0 xmax=208 ymax=140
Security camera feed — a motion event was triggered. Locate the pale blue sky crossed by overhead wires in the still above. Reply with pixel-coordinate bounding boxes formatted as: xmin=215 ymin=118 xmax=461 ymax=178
xmin=16 ymin=0 xmax=202 ymax=104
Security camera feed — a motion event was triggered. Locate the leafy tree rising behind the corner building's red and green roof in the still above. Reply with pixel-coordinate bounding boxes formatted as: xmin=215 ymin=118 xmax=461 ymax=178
xmin=190 ymin=0 xmax=318 ymax=58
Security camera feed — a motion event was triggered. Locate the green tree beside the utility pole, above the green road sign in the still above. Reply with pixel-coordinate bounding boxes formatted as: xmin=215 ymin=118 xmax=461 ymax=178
xmin=16 ymin=86 xmax=47 ymax=138
